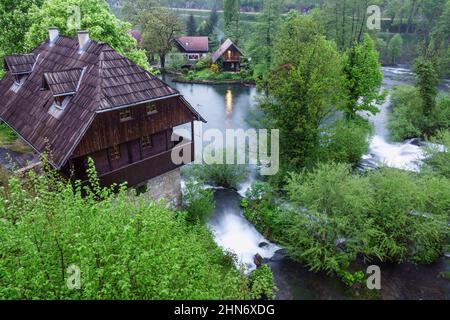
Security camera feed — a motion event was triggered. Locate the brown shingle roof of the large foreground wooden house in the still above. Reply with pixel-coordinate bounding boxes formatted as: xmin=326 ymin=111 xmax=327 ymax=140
xmin=0 ymin=36 xmax=191 ymax=168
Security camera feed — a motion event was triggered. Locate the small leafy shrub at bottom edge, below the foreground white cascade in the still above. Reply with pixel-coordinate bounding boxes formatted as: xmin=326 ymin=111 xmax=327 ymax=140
xmin=250 ymin=265 xmax=276 ymax=300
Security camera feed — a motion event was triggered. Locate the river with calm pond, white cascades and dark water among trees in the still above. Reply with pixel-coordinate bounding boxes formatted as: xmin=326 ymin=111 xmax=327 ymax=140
xmin=163 ymin=68 xmax=450 ymax=300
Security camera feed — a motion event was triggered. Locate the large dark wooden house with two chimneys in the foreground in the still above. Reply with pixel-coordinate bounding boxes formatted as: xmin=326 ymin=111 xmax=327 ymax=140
xmin=0 ymin=28 xmax=204 ymax=206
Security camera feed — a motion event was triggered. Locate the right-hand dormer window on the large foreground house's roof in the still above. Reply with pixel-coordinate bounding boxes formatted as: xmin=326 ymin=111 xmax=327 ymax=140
xmin=41 ymin=69 xmax=85 ymax=109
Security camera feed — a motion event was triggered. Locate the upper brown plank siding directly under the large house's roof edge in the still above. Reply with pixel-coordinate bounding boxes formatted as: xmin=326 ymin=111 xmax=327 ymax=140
xmin=72 ymin=97 xmax=196 ymax=158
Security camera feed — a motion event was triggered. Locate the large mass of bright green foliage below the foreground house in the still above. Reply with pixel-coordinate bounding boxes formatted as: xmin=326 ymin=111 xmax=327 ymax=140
xmin=0 ymin=162 xmax=250 ymax=299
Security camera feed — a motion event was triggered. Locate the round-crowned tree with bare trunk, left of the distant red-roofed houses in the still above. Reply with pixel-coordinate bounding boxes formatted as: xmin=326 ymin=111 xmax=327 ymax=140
xmin=140 ymin=8 xmax=184 ymax=70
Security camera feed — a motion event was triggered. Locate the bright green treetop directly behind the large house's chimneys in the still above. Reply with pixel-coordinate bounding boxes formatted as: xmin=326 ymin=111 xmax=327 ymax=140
xmin=25 ymin=0 xmax=151 ymax=70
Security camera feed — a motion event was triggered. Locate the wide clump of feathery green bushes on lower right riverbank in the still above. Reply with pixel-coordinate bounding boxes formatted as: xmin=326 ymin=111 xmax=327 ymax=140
xmin=282 ymin=164 xmax=450 ymax=274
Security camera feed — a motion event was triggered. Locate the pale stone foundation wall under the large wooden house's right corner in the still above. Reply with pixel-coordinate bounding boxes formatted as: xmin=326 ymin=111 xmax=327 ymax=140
xmin=142 ymin=169 xmax=181 ymax=209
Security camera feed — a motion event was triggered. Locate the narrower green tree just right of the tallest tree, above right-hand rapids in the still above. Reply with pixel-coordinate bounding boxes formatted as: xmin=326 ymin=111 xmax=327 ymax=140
xmin=344 ymin=35 xmax=384 ymax=119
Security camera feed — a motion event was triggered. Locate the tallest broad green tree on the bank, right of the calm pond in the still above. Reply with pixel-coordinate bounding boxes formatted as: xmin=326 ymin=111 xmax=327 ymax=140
xmin=260 ymin=12 xmax=345 ymax=167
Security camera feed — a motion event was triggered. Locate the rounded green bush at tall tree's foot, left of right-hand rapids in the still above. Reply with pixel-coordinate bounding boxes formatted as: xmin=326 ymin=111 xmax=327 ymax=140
xmin=319 ymin=117 xmax=372 ymax=165
